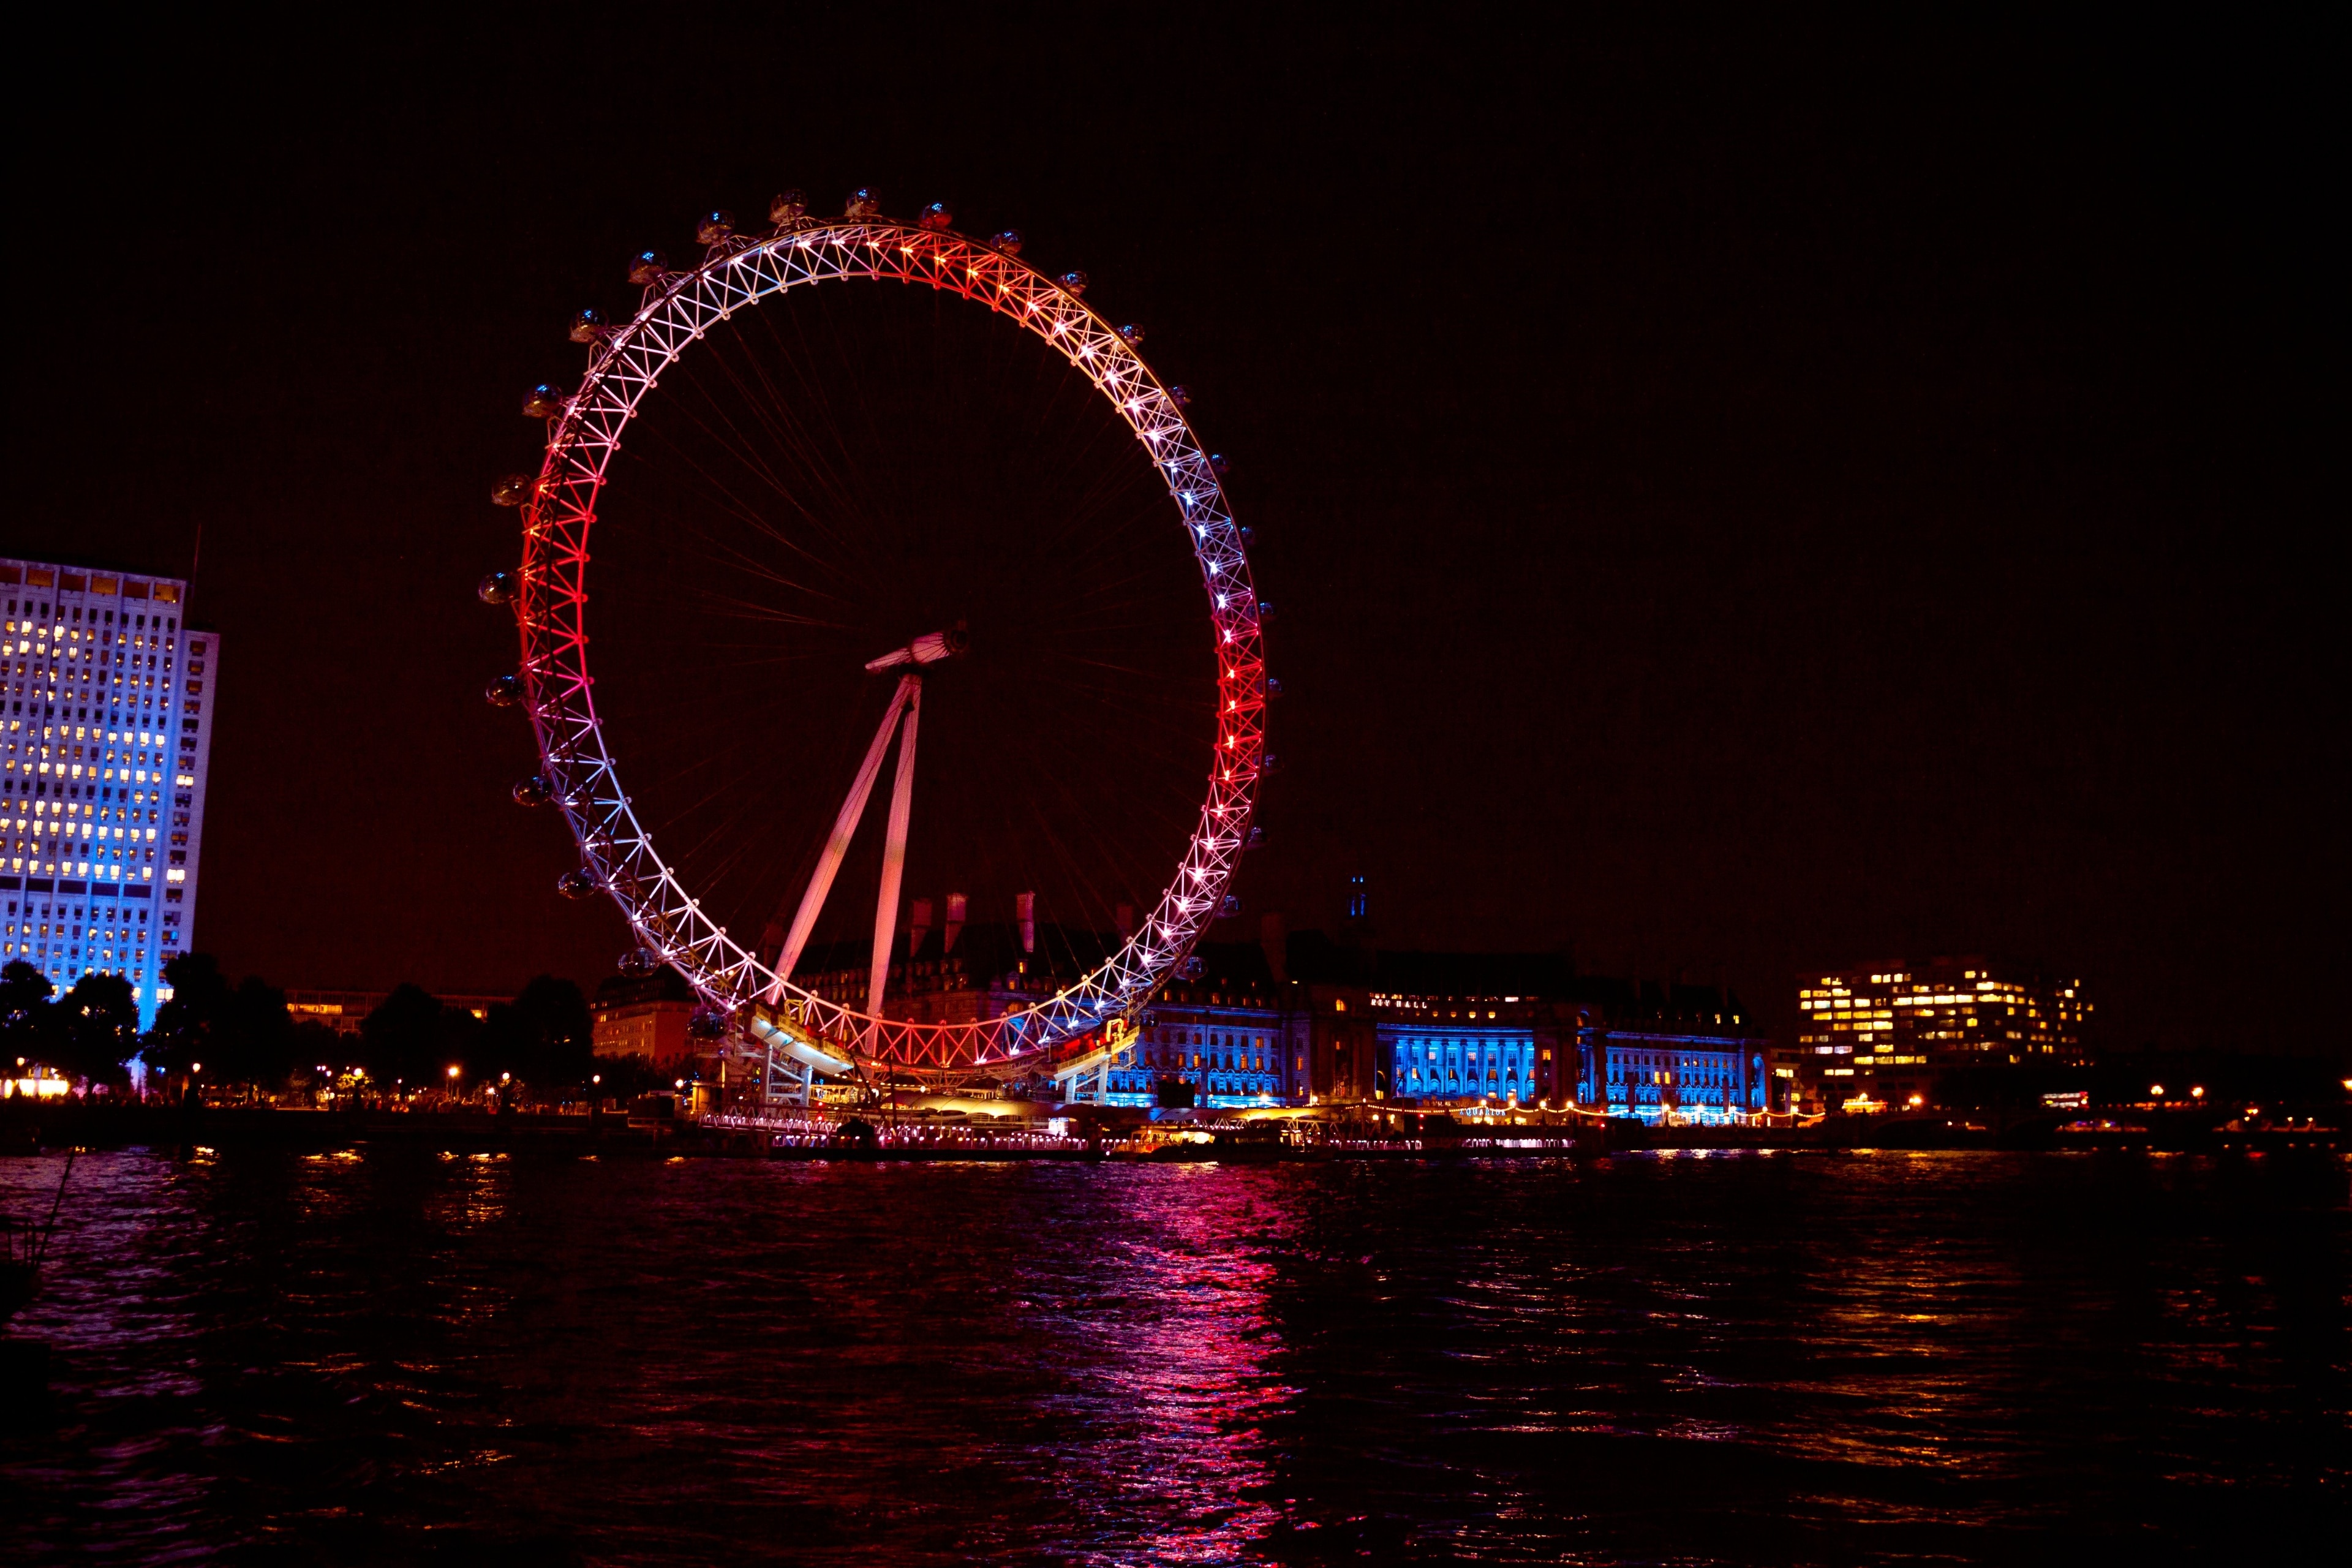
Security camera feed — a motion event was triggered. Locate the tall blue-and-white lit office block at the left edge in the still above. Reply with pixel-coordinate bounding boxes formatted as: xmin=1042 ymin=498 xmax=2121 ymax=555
xmin=0 ymin=557 xmax=221 ymax=1027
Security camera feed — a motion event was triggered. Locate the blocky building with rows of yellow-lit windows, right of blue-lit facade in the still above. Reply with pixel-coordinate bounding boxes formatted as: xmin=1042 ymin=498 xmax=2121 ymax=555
xmin=1797 ymin=957 xmax=2091 ymax=1110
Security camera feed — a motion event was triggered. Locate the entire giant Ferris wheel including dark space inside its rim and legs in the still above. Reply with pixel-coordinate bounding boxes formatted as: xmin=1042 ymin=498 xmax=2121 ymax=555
xmin=482 ymin=190 xmax=1277 ymax=1105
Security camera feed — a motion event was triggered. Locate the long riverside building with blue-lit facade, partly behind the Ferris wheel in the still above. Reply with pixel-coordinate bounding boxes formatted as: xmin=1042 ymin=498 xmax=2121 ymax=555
xmin=762 ymin=879 xmax=1787 ymax=1121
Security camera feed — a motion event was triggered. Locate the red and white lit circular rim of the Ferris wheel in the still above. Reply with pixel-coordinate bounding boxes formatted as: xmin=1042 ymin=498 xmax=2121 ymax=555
xmin=518 ymin=216 xmax=1265 ymax=1069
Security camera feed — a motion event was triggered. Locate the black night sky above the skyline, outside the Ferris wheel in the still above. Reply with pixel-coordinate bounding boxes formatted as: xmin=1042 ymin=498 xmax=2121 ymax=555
xmin=0 ymin=7 xmax=2345 ymax=1049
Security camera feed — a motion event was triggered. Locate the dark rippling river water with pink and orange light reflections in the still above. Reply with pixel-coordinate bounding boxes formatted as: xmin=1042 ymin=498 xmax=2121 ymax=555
xmin=0 ymin=1152 xmax=2352 ymax=1568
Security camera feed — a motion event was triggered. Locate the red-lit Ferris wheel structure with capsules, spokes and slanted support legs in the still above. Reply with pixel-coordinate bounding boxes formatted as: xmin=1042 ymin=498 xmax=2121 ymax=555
xmin=482 ymin=190 xmax=1270 ymax=1086
